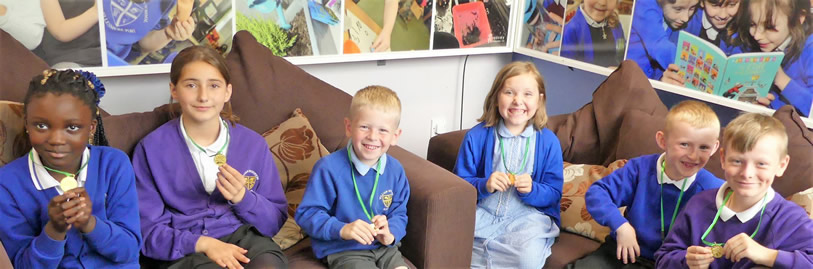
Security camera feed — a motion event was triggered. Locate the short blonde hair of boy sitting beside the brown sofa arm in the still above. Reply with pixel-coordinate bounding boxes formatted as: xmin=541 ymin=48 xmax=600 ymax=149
xmin=350 ymin=85 xmax=401 ymax=127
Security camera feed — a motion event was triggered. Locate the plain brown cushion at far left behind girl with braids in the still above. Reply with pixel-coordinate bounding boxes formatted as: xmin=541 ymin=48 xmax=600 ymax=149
xmin=0 ymin=30 xmax=49 ymax=102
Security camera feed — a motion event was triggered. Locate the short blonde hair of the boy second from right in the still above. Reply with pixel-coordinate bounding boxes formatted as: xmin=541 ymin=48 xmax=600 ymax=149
xmin=664 ymin=100 xmax=720 ymax=134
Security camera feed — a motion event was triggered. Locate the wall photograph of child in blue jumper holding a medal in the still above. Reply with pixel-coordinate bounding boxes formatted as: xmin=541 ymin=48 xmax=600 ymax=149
xmin=102 ymin=0 xmax=233 ymax=66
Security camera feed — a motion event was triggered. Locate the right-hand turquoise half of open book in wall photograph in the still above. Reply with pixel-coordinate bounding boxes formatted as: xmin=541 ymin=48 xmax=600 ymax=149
xmin=716 ymin=52 xmax=785 ymax=103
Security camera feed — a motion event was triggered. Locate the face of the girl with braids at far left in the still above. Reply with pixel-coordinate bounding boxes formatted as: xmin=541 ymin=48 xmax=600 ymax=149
xmin=25 ymin=93 xmax=96 ymax=173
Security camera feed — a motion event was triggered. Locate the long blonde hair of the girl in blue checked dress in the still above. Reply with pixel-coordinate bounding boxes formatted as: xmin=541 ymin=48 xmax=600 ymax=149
xmin=477 ymin=62 xmax=548 ymax=130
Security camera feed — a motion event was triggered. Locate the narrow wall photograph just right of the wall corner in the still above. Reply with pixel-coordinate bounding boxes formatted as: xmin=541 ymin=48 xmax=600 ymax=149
xmin=519 ymin=0 xmax=567 ymax=55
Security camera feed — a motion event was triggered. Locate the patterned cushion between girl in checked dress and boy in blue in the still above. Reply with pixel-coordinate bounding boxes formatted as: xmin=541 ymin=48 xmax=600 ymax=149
xmin=560 ymin=159 xmax=627 ymax=243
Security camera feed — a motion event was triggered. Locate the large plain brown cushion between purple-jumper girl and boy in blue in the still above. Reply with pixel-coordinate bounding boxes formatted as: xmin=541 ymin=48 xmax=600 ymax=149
xmin=226 ymin=31 xmax=351 ymax=152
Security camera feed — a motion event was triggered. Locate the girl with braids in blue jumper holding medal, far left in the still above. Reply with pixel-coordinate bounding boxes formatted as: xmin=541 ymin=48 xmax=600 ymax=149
xmin=0 ymin=70 xmax=141 ymax=268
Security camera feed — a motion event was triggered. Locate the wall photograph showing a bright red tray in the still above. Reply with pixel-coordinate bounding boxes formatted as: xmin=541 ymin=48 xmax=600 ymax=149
xmin=432 ymin=0 xmax=508 ymax=49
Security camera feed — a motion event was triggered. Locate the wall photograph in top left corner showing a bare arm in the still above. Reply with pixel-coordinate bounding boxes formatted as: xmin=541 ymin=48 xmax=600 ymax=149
xmin=0 ymin=0 xmax=102 ymax=68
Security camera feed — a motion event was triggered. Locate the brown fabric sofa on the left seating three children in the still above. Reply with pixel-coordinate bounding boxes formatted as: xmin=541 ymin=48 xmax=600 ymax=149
xmin=0 ymin=31 xmax=476 ymax=268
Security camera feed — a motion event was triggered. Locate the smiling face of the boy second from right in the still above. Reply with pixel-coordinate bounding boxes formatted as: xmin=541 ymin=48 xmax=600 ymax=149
xmin=655 ymin=121 xmax=720 ymax=180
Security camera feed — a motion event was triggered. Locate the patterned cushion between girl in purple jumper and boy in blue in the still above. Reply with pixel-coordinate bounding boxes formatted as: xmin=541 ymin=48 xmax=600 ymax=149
xmin=262 ymin=108 xmax=330 ymax=249
